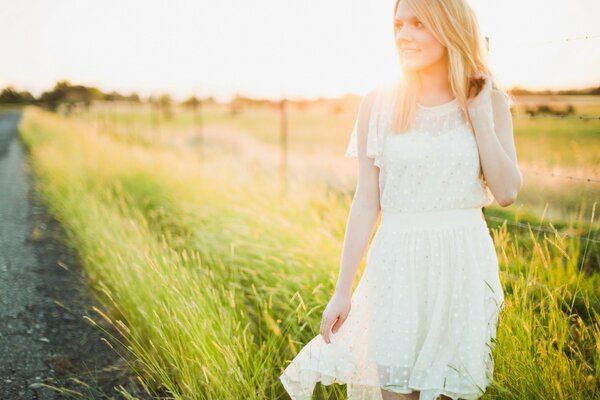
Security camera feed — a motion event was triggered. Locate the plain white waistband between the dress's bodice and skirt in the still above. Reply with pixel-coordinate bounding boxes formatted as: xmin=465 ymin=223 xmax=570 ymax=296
xmin=381 ymin=207 xmax=486 ymax=228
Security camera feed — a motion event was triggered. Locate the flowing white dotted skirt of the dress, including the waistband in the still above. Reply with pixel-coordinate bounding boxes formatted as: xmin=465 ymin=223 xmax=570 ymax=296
xmin=280 ymin=208 xmax=504 ymax=400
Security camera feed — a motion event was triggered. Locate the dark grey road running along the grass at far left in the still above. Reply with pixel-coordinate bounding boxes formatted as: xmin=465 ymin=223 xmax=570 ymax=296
xmin=0 ymin=111 xmax=140 ymax=400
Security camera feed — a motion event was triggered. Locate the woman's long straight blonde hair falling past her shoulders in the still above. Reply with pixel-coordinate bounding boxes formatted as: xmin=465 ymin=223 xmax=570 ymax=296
xmin=392 ymin=0 xmax=512 ymax=132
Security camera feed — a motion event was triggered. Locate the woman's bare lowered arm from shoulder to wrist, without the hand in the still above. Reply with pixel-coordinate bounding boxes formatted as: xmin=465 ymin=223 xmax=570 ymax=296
xmin=335 ymin=90 xmax=380 ymax=296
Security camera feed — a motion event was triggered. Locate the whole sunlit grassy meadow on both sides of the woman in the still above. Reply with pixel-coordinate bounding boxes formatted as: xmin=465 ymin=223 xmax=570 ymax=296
xmin=20 ymin=98 xmax=600 ymax=400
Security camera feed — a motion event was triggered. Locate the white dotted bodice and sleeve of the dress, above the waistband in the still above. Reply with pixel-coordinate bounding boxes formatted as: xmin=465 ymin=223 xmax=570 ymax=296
xmin=346 ymin=84 xmax=494 ymax=211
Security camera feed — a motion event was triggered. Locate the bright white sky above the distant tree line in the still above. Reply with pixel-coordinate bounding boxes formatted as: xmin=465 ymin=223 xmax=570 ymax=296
xmin=0 ymin=0 xmax=600 ymax=100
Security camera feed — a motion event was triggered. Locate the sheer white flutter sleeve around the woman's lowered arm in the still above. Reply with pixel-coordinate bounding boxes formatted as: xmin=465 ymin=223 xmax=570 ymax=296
xmin=345 ymin=89 xmax=383 ymax=168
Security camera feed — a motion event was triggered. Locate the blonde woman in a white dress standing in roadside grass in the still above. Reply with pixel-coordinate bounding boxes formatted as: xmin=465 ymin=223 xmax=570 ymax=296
xmin=280 ymin=0 xmax=522 ymax=400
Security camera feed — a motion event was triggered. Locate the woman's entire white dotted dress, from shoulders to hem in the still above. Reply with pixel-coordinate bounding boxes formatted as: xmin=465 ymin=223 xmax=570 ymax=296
xmin=280 ymin=83 xmax=504 ymax=400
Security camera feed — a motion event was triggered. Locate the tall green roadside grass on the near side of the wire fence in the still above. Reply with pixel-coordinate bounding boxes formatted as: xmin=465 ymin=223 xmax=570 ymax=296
xmin=20 ymin=107 xmax=600 ymax=399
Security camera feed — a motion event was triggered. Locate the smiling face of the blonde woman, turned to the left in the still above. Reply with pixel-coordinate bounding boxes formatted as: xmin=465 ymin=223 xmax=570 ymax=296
xmin=394 ymin=1 xmax=446 ymax=71
